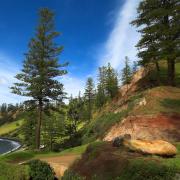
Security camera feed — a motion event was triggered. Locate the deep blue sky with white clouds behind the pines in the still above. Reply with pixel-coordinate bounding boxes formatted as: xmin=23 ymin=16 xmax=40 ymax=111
xmin=0 ymin=0 xmax=140 ymax=103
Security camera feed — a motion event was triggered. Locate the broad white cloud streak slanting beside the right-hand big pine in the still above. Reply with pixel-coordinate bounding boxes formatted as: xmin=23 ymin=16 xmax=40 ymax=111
xmin=99 ymin=0 xmax=140 ymax=69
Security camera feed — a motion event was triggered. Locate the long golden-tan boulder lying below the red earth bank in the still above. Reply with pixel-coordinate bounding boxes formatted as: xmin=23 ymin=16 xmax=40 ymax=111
xmin=123 ymin=140 xmax=177 ymax=157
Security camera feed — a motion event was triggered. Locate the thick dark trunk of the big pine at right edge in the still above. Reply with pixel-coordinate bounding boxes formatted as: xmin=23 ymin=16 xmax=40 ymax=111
xmin=167 ymin=59 xmax=175 ymax=86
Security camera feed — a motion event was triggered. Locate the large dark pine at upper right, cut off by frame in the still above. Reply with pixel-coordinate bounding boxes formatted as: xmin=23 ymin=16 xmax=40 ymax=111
xmin=132 ymin=0 xmax=180 ymax=85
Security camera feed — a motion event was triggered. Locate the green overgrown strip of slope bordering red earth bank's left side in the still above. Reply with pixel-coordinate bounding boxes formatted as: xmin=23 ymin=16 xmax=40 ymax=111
xmin=82 ymin=111 xmax=127 ymax=143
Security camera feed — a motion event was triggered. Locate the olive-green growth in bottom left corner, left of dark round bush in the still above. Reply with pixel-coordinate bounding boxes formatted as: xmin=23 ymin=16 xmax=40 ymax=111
xmin=0 ymin=162 xmax=29 ymax=180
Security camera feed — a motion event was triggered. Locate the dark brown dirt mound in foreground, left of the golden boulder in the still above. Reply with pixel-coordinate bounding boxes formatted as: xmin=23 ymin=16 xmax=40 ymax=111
xmin=70 ymin=142 xmax=141 ymax=180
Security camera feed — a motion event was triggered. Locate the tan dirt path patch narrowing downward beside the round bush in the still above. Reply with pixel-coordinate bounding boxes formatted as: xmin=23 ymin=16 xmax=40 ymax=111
xmin=40 ymin=154 xmax=80 ymax=177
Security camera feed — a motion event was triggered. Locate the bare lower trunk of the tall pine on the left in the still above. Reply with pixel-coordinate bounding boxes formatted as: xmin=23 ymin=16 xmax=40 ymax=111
xmin=36 ymin=100 xmax=43 ymax=150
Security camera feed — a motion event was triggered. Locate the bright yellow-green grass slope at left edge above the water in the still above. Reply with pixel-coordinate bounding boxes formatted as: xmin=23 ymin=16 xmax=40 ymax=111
xmin=0 ymin=119 xmax=24 ymax=136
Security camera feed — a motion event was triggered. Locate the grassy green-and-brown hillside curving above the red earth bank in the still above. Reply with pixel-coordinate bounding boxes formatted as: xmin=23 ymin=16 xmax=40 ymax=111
xmin=83 ymin=86 xmax=180 ymax=143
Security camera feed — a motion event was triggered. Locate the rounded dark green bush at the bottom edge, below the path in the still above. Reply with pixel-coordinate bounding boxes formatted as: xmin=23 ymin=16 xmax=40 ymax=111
xmin=28 ymin=160 xmax=55 ymax=180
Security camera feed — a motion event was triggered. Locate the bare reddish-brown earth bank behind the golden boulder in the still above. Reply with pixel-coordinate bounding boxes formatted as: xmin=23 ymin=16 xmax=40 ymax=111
xmin=104 ymin=115 xmax=180 ymax=142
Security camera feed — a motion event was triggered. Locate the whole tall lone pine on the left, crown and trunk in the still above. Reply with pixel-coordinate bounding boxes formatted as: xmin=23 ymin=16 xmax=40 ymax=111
xmin=11 ymin=8 xmax=66 ymax=149
